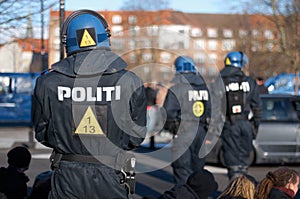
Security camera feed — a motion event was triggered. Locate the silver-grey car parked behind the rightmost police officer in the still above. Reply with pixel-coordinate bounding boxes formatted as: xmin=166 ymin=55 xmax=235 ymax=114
xmin=206 ymin=94 xmax=300 ymax=166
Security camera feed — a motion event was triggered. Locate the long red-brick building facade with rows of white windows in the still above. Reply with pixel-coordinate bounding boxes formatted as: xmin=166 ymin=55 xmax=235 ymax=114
xmin=48 ymin=10 xmax=279 ymax=81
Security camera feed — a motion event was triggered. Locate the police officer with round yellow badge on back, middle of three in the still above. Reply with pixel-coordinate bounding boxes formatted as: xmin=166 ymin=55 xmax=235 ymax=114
xmin=163 ymin=56 xmax=210 ymax=185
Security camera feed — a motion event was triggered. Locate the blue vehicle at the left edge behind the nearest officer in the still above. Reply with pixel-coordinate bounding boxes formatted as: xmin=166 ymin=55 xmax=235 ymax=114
xmin=0 ymin=73 xmax=40 ymax=127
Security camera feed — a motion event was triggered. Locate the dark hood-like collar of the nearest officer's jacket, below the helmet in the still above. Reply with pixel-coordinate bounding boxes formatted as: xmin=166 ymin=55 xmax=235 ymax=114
xmin=52 ymin=47 xmax=127 ymax=77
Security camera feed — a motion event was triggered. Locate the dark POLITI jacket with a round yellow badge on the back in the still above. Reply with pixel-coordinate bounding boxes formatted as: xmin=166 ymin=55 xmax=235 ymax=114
xmin=163 ymin=73 xmax=211 ymax=127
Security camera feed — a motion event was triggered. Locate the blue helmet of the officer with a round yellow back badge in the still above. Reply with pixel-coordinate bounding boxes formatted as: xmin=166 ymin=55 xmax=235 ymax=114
xmin=174 ymin=56 xmax=196 ymax=73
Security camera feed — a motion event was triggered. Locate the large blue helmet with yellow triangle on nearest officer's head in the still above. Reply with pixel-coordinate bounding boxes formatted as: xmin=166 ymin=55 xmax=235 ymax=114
xmin=62 ymin=10 xmax=110 ymax=56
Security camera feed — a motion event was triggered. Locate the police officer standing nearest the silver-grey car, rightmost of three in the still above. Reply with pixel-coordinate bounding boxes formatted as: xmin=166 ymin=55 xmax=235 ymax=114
xmin=221 ymin=51 xmax=261 ymax=179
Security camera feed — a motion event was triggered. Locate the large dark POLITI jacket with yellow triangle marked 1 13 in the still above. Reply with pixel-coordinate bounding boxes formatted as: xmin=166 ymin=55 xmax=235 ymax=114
xmin=32 ymin=48 xmax=146 ymax=155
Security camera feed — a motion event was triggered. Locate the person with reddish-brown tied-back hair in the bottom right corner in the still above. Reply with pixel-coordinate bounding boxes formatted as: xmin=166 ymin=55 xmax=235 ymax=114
xmin=255 ymin=167 xmax=299 ymax=199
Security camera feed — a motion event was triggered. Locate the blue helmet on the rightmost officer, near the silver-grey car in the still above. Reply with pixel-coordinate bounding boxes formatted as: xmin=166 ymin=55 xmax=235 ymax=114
xmin=224 ymin=51 xmax=249 ymax=68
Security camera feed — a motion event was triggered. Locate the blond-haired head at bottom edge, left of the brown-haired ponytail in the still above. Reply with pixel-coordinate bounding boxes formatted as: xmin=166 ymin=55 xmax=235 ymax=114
xmin=218 ymin=174 xmax=256 ymax=199
